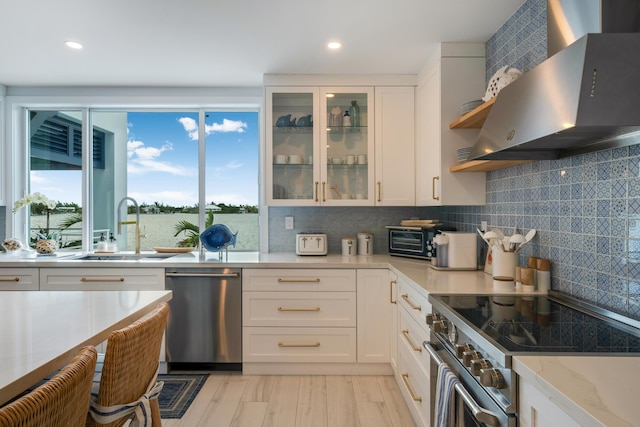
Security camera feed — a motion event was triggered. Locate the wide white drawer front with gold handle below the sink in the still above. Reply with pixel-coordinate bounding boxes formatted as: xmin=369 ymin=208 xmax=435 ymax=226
xmin=40 ymin=268 xmax=164 ymax=291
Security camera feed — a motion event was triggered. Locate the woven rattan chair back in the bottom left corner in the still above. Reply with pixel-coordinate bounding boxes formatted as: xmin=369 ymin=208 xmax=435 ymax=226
xmin=0 ymin=346 xmax=97 ymax=427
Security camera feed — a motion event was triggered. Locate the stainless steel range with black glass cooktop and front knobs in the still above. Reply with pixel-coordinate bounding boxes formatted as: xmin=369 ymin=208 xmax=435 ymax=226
xmin=423 ymin=291 xmax=640 ymax=427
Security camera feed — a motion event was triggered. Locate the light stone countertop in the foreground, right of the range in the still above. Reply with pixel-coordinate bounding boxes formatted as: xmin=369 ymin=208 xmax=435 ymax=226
xmin=513 ymin=356 xmax=640 ymax=427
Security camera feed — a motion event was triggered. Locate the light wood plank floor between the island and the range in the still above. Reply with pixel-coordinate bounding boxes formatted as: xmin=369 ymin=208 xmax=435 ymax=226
xmin=162 ymin=373 xmax=415 ymax=427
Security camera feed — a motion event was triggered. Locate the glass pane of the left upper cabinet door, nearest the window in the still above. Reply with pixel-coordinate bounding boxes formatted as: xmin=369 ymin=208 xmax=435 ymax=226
xmin=271 ymin=93 xmax=314 ymax=200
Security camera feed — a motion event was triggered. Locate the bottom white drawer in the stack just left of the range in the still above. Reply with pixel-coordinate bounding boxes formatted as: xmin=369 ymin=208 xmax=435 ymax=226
xmin=398 ymin=345 xmax=435 ymax=427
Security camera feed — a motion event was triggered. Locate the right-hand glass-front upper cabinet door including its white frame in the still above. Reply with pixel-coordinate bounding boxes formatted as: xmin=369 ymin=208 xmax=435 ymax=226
xmin=320 ymin=87 xmax=375 ymax=206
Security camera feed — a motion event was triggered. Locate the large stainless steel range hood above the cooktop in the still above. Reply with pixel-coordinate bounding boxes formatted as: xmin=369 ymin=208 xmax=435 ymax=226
xmin=470 ymin=0 xmax=640 ymax=160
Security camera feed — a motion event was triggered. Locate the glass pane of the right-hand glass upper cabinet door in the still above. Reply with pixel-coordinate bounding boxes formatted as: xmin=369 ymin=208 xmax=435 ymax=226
xmin=326 ymin=93 xmax=370 ymax=200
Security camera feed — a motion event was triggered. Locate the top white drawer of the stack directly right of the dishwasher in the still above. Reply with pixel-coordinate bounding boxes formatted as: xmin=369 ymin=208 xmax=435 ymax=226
xmin=242 ymin=269 xmax=356 ymax=292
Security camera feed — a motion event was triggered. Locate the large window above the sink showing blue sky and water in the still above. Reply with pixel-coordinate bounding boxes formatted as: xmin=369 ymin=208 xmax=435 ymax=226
xmin=28 ymin=110 xmax=259 ymax=251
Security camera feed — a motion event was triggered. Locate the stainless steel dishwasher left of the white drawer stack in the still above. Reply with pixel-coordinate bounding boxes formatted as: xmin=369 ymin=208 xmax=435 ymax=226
xmin=165 ymin=268 xmax=242 ymax=370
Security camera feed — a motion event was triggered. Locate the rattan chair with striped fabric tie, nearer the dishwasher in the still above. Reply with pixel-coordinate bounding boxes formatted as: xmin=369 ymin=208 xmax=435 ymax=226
xmin=86 ymin=303 xmax=169 ymax=427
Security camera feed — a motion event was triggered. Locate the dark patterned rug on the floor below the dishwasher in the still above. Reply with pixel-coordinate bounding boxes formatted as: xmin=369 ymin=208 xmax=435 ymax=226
xmin=158 ymin=374 xmax=209 ymax=418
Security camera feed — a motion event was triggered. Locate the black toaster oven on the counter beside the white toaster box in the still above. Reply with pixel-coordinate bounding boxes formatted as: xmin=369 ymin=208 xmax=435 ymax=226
xmin=385 ymin=225 xmax=455 ymax=259
